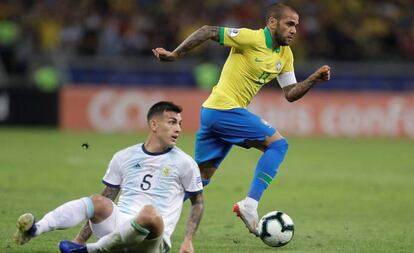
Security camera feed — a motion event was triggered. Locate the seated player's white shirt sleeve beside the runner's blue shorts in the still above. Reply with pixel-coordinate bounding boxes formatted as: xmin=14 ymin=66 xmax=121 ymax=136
xmin=181 ymin=158 xmax=203 ymax=193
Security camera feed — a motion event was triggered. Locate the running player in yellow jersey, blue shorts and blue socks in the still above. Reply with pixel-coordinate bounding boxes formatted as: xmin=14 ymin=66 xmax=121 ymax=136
xmin=153 ymin=3 xmax=330 ymax=235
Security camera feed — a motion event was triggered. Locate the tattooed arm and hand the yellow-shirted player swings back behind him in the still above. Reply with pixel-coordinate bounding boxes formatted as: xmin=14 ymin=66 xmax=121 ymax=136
xmin=152 ymin=25 xmax=220 ymax=61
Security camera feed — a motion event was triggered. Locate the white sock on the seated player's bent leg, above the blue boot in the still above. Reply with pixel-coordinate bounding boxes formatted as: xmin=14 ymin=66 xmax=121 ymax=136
xmin=86 ymin=220 xmax=150 ymax=253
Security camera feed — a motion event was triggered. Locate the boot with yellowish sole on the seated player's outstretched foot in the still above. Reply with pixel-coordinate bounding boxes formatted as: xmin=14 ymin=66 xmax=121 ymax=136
xmin=13 ymin=213 xmax=36 ymax=245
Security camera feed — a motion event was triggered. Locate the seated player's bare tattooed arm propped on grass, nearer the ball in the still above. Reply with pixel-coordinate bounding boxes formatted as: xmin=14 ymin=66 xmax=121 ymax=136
xmin=179 ymin=193 xmax=204 ymax=253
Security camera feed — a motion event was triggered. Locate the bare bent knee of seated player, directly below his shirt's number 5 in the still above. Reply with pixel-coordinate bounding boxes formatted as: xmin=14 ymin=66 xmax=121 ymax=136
xmin=135 ymin=205 xmax=164 ymax=239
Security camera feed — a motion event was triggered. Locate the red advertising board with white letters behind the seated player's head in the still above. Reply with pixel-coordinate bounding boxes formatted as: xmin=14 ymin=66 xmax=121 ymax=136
xmin=60 ymin=86 xmax=208 ymax=132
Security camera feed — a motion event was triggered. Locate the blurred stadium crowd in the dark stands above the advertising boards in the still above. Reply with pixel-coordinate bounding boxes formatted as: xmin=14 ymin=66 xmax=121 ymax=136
xmin=0 ymin=0 xmax=414 ymax=90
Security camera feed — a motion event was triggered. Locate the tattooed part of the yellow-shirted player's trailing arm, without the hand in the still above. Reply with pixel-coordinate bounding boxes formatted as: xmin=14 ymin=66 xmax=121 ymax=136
xmin=174 ymin=25 xmax=220 ymax=57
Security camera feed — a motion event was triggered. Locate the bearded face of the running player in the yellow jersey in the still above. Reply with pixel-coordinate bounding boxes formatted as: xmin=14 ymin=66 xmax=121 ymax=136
xmin=275 ymin=11 xmax=299 ymax=46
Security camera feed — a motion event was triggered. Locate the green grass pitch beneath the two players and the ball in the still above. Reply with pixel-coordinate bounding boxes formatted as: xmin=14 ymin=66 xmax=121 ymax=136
xmin=0 ymin=128 xmax=414 ymax=253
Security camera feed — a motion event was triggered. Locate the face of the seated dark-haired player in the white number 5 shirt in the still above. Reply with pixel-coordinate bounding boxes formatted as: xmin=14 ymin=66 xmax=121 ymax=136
xmin=156 ymin=111 xmax=182 ymax=147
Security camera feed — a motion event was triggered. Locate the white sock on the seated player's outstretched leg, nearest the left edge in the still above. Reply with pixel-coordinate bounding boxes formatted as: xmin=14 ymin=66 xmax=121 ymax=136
xmin=35 ymin=197 xmax=94 ymax=236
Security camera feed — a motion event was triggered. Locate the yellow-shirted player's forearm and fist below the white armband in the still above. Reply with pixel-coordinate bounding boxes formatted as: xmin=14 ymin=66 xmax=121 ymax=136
xmin=283 ymin=65 xmax=331 ymax=102
